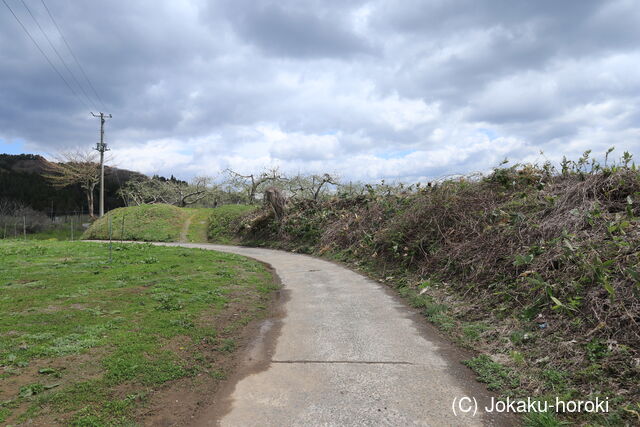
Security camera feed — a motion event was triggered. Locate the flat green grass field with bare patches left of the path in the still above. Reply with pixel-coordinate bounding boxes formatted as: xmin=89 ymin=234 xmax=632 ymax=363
xmin=0 ymin=240 xmax=276 ymax=425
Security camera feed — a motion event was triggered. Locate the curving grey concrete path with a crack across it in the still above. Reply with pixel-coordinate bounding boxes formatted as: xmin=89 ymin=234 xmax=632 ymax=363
xmin=160 ymin=244 xmax=514 ymax=427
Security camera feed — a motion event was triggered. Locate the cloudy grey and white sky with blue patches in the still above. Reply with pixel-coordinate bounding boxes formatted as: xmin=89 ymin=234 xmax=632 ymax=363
xmin=0 ymin=0 xmax=640 ymax=181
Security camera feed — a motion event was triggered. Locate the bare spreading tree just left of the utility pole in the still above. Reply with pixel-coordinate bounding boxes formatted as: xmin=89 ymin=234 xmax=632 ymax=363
xmin=45 ymin=151 xmax=100 ymax=218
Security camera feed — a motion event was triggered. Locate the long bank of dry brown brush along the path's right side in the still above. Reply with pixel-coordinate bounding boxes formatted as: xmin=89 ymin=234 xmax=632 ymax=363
xmin=238 ymin=155 xmax=640 ymax=425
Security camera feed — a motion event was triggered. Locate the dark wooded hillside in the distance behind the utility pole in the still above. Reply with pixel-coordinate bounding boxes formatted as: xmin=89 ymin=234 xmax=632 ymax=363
xmin=0 ymin=154 xmax=143 ymax=214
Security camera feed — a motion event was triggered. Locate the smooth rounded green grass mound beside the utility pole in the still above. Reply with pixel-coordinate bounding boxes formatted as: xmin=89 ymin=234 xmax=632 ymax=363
xmin=82 ymin=204 xmax=190 ymax=242
